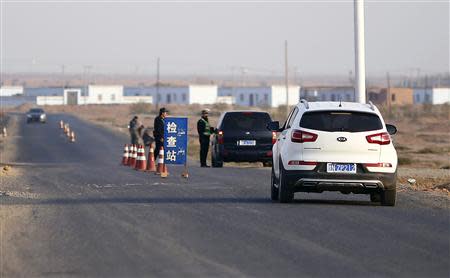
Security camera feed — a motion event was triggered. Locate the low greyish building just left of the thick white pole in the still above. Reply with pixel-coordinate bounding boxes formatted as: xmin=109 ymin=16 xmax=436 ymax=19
xmin=300 ymin=87 xmax=356 ymax=101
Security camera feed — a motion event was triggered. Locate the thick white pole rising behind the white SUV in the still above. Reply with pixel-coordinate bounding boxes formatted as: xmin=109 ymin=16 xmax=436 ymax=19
xmin=354 ymin=0 xmax=366 ymax=103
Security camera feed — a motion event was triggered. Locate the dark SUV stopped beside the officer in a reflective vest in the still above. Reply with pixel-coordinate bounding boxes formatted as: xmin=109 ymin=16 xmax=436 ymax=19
xmin=211 ymin=111 xmax=276 ymax=167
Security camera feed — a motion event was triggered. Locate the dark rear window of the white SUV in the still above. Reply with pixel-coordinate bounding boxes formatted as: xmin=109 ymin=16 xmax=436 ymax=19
xmin=300 ymin=111 xmax=383 ymax=132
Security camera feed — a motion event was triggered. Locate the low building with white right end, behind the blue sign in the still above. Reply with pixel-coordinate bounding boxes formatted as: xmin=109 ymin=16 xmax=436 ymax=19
xmin=124 ymin=85 xmax=217 ymax=105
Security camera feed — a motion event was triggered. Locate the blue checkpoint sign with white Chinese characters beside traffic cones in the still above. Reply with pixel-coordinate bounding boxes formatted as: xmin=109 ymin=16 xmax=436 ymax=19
xmin=164 ymin=117 xmax=188 ymax=164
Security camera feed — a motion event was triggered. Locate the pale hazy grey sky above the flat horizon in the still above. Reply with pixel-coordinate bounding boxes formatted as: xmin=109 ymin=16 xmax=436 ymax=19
xmin=1 ymin=0 xmax=449 ymax=75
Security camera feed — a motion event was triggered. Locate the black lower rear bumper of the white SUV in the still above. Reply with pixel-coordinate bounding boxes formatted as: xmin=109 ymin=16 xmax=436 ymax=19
xmin=284 ymin=167 xmax=397 ymax=194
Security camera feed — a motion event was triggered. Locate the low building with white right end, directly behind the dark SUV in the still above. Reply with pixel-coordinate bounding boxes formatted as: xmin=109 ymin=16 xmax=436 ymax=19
xmin=219 ymin=85 xmax=300 ymax=107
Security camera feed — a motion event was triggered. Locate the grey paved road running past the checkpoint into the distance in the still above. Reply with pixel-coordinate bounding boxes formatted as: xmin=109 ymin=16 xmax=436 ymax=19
xmin=0 ymin=112 xmax=450 ymax=277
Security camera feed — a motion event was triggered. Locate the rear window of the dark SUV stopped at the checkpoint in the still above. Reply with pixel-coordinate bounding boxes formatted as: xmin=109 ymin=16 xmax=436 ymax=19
xmin=222 ymin=112 xmax=271 ymax=131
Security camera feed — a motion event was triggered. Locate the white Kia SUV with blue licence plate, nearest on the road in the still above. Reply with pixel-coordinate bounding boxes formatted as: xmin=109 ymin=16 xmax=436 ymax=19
xmin=268 ymin=100 xmax=397 ymax=206
